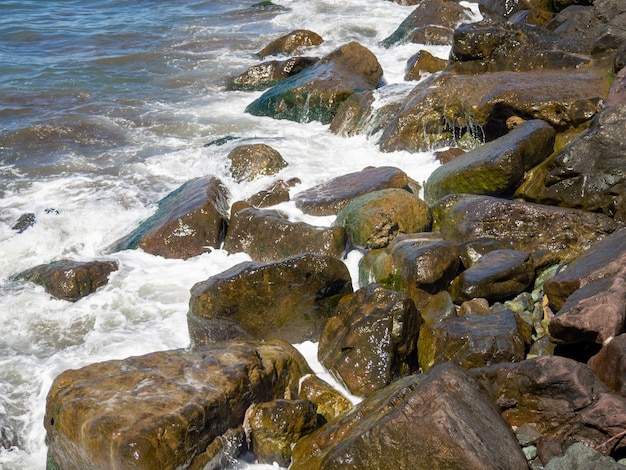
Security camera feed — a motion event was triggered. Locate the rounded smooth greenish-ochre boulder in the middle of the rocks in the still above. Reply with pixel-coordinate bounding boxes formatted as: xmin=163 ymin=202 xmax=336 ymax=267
xmin=333 ymin=188 xmax=432 ymax=252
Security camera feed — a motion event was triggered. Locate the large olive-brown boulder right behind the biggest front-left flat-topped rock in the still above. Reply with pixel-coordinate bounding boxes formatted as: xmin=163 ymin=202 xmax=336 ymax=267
xmin=187 ymin=254 xmax=352 ymax=346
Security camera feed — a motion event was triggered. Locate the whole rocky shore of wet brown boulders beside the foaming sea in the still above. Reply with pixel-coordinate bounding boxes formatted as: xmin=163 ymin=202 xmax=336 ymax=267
xmin=16 ymin=0 xmax=626 ymax=470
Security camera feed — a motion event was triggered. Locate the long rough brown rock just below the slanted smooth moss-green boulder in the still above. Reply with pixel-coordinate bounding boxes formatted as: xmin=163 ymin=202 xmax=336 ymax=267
xmin=431 ymin=195 xmax=618 ymax=266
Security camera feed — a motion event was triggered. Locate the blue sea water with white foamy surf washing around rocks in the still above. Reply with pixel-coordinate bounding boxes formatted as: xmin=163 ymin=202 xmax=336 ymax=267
xmin=0 ymin=0 xmax=478 ymax=470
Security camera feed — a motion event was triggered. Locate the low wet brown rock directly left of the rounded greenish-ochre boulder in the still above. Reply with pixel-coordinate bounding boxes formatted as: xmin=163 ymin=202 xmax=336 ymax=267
xmin=224 ymin=208 xmax=346 ymax=262
